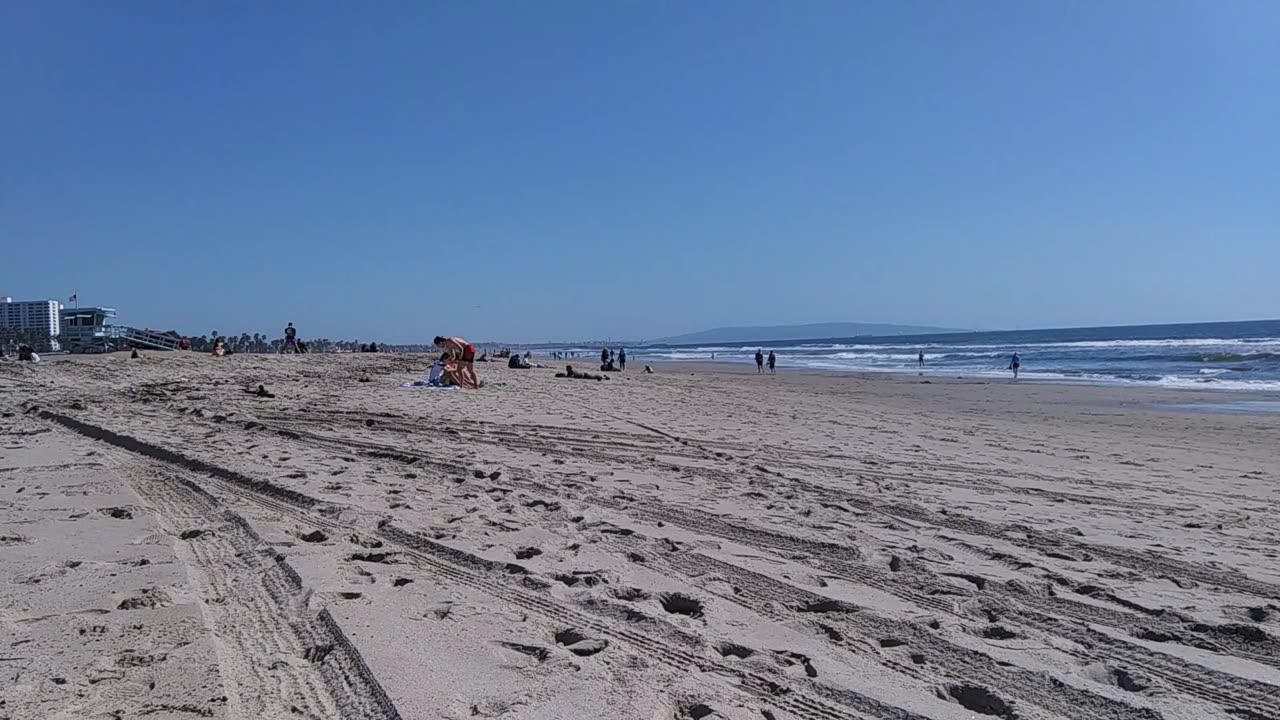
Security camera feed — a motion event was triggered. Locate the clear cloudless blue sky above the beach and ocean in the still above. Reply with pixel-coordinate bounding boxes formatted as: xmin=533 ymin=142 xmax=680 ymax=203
xmin=0 ymin=0 xmax=1280 ymax=341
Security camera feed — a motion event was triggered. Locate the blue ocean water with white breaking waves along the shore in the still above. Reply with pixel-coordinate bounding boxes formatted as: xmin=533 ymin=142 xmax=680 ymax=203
xmin=624 ymin=320 xmax=1280 ymax=391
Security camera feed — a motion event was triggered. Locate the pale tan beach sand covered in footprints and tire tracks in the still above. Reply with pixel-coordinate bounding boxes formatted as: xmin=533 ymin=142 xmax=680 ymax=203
xmin=0 ymin=354 xmax=1280 ymax=720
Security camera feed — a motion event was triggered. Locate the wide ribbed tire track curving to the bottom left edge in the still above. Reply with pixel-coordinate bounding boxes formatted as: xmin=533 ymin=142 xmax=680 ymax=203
xmin=108 ymin=450 xmax=401 ymax=720
